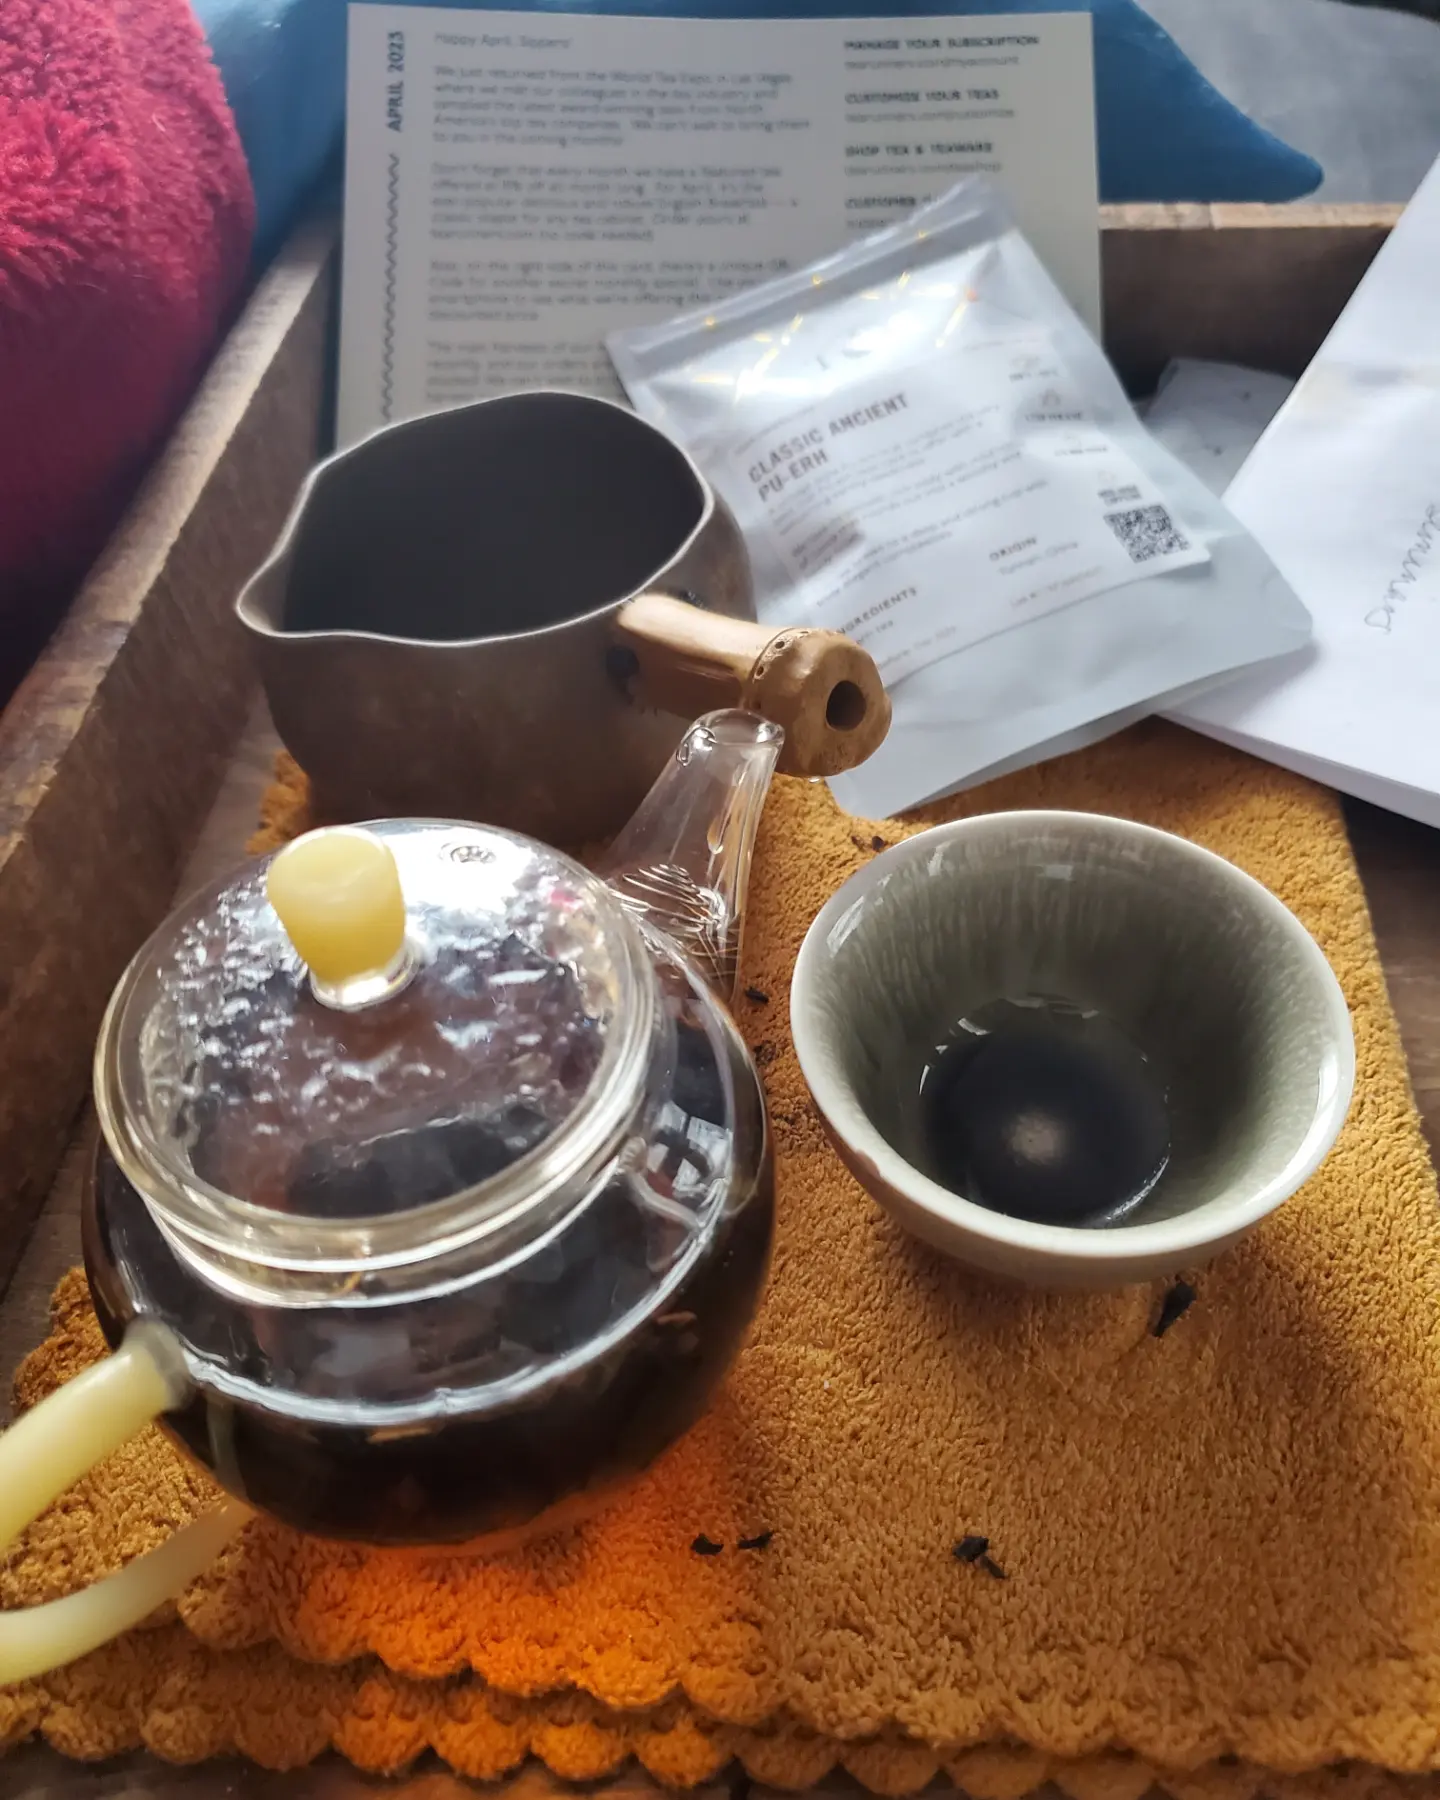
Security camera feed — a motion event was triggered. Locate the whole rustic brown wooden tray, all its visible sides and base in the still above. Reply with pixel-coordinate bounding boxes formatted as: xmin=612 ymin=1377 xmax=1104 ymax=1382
xmin=0 ymin=205 xmax=1440 ymax=1800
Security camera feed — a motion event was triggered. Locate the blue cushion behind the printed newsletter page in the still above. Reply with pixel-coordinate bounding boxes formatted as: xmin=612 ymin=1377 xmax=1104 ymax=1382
xmin=194 ymin=0 xmax=1321 ymax=254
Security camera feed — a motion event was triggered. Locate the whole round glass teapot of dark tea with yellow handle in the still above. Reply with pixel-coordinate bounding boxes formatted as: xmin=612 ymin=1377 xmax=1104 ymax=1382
xmin=0 ymin=713 xmax=783 ymax=1683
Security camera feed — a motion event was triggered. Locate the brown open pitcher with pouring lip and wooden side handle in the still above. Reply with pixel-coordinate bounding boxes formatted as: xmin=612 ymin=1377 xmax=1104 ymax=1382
xmin=238 ymin=392 xmax=889 ymax=844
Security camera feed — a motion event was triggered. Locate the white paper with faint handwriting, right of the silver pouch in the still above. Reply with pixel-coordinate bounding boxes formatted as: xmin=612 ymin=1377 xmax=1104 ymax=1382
xmin=1183 ymin=162 xmax=1440 ymax=826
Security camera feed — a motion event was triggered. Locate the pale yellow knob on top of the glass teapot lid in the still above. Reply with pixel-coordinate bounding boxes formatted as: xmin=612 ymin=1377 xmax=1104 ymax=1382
xmin=265 ymin=826 xmax=405 ymax=990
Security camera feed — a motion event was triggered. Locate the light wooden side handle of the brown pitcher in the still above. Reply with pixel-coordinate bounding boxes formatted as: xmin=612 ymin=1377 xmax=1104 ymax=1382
xmin=616 ymin=594 xmax=889 ymax=776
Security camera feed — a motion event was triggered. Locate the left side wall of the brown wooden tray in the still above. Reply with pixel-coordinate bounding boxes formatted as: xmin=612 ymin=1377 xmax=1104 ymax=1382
xmin=0 ymin=223 xmax=337 ymax=1291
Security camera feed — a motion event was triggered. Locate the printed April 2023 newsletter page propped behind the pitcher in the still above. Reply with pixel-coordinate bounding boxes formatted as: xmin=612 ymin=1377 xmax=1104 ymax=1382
xmin=340 ymin=5 xmax=1098 ymax=443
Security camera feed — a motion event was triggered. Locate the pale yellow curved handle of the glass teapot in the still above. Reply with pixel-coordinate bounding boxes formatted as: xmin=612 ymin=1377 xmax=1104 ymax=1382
xmin=0 ymin=1325 xmax=250 ymax=1687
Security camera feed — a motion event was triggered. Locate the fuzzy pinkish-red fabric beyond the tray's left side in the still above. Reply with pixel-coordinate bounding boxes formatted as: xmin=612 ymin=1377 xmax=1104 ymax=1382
xmin=0 ymin=0 xmax=254 ymax=698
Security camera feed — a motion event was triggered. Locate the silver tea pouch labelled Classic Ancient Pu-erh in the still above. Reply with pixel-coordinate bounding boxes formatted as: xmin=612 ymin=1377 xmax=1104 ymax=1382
xmin=608 ymin=180 xmax=1310 ymax=817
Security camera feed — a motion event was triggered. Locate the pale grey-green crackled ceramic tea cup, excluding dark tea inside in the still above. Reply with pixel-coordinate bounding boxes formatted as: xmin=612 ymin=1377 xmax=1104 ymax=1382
xmin=790 ymin=812 xmax=1355 ymax=1289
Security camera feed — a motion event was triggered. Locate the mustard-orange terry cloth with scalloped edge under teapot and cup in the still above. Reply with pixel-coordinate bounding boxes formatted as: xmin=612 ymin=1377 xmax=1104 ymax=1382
xmin=0 ymin=724 xmax=1440 ymax=1800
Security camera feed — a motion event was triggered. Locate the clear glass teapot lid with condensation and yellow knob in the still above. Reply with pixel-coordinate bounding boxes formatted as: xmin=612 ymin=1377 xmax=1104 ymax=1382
xmin=95 ymin=819 xmax=655 ymax=1264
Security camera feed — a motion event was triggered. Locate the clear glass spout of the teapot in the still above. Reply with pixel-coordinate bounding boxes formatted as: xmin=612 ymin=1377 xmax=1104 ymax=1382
xmin=599 ymin=711 xmax=785 ymax=1004
